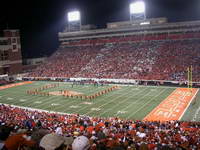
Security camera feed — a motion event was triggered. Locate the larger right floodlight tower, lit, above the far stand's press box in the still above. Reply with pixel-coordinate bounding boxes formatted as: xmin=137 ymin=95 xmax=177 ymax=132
xmin=130 ymin=0 xmax=146 ymax=21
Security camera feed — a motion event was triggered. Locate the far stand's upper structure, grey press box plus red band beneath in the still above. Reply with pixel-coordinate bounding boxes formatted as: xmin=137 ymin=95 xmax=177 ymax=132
xmin=58 ymin=18 xmax=200 ymax=47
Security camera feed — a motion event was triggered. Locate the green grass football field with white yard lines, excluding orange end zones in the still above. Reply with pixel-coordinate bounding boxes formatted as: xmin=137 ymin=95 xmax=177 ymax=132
xmin=0 ymin=82 xmax=200 ymax=121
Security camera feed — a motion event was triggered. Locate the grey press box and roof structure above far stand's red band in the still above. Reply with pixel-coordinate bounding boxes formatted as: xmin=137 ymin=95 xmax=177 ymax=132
xmin=58 ymin=18 xmax=200 ymax=42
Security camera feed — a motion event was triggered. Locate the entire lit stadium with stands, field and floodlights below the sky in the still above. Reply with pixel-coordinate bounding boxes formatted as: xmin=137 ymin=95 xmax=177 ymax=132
xmin=0 ymin=1 xmax=200 ymax=150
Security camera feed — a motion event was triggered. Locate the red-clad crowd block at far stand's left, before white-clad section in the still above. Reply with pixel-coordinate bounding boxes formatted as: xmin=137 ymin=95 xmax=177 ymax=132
xmin=29 ymin=46 xmax=102 ymax=78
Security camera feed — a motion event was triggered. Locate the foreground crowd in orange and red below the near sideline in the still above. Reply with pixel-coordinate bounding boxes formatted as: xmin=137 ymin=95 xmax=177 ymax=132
xmin=0 ymin=105 xmax=200 ymax=150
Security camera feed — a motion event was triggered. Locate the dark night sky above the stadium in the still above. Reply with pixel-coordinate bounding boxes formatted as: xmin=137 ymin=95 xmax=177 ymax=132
xmin=0 ymin=0 xmax=200 ymax=57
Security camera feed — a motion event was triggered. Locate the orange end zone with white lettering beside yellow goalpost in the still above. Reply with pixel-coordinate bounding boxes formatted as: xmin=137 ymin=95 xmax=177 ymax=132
xmin=143 ymin=88 xmax=198 ymax=121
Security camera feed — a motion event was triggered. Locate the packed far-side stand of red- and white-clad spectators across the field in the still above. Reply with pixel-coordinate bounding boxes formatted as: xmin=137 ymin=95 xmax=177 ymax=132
xmin=29 ymin=33 xmax=200 ymax=82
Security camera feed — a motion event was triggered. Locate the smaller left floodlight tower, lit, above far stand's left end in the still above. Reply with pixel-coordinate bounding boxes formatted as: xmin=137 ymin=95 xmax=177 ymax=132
xmin=67 ymin=11 xmax=81 ymax=32
